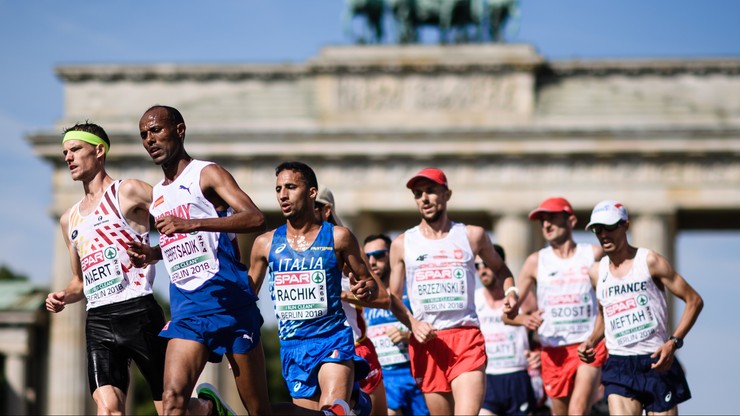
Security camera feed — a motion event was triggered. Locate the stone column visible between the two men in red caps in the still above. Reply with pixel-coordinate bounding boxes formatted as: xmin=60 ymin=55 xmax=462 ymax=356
xmin=493 ymin=212 xmax=533 ymax=278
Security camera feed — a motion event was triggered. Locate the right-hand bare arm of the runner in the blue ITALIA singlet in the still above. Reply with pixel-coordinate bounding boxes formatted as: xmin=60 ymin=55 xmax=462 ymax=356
xmin=334 ymin=226 xmax=390 ymax=309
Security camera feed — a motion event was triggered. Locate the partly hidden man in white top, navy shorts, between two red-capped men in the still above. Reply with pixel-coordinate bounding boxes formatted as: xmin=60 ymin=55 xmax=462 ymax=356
xmin=475 ymin=244 xmax=539 ymax=415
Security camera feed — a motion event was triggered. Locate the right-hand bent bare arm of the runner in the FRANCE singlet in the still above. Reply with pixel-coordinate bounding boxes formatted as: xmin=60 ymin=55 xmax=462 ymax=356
xmin=647 ymin=251 xmax=704 ymax=371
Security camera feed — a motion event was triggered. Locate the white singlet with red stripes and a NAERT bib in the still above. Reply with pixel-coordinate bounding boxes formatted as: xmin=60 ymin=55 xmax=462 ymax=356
xmin=67 ymin=180 xmax=154 ymax=310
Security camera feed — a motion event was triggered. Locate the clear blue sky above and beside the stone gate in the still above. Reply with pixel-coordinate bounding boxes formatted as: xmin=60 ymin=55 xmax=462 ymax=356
xmin=0 ymin=0 xmax=740 ymax=414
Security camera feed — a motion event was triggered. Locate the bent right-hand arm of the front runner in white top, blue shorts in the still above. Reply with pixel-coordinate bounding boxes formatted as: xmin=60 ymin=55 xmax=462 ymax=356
xmin=155 ymin=164 xmax=265 ymax=235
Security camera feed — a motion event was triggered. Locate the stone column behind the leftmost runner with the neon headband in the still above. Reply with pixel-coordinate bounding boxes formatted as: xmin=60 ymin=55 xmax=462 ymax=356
xmin=46 ymin=232 xmax=90 ymax=415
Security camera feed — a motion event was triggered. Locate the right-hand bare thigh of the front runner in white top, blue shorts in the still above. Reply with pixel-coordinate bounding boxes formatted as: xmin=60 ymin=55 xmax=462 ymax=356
xmin=226 ymin=343 xmax=272 ymax=415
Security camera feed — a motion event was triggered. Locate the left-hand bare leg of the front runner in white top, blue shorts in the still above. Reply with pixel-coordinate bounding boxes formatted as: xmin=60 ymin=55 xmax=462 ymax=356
xmin=162 ymin=338 xmax=211 ymax=415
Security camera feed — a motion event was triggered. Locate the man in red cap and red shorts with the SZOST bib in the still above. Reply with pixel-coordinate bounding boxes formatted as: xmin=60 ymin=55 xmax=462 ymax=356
xmin=504 ymin=197 xmax=606 ymax=415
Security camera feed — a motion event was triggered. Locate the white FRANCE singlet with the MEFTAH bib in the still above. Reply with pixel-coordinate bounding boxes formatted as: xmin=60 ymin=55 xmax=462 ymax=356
xmin=596 ymin=248 xmax=668 ymax=355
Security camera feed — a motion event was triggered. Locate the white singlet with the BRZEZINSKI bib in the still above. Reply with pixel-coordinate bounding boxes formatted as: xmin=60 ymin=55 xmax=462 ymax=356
xmin=404 ymin=222 xmax=479 ymax=329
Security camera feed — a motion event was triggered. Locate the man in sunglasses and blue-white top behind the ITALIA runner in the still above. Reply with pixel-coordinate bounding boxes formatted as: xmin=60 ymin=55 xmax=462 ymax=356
xmin=363 ymin=234 xmax=429 ymax=416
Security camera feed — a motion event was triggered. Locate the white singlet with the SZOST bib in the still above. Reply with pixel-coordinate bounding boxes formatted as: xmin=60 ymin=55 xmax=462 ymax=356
xmin=537 ymin=244 xmax=598 ymax=347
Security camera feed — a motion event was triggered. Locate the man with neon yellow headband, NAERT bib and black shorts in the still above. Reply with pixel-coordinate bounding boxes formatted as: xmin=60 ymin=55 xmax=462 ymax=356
xmin=46 ymin=123 xmax=167 ymax=414
